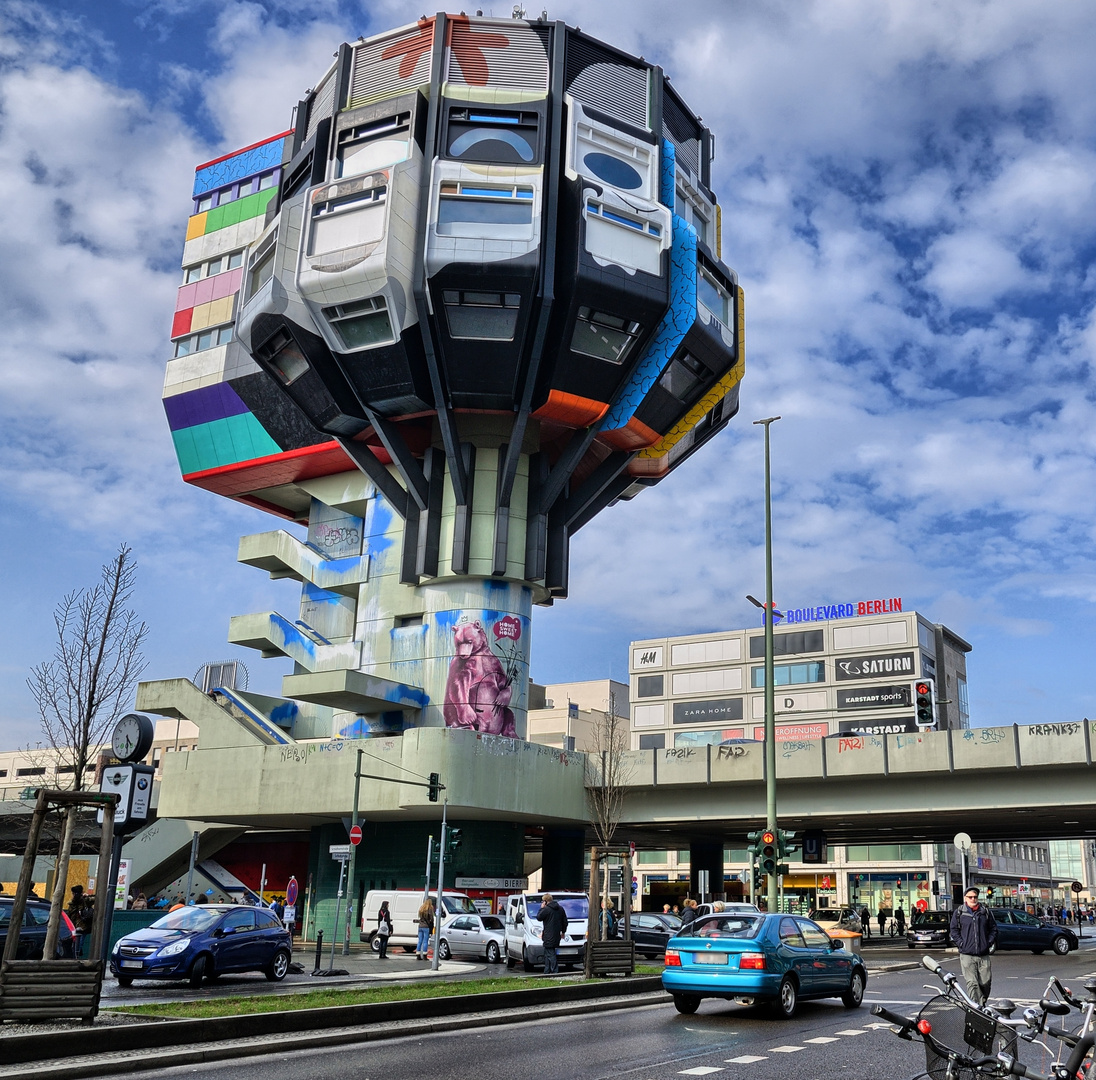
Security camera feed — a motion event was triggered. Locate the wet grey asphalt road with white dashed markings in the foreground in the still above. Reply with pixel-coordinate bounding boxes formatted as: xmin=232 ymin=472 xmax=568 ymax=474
xmin=87 ymin=951 xmax=1096 ymax=1080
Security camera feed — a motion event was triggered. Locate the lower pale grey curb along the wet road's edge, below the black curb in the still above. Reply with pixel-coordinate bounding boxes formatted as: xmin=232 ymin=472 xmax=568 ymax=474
xmin=0 ymin=988 xmax=669 ymax=1080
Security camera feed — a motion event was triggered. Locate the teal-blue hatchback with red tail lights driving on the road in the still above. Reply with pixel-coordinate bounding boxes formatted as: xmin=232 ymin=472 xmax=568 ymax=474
xmin=662 ymin=913 xmax=868 ymax=1019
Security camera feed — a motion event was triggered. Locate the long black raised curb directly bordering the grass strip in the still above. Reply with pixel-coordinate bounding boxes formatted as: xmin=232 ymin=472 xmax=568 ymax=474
xmin=0 ymin=975 xmax=662 ymax=1076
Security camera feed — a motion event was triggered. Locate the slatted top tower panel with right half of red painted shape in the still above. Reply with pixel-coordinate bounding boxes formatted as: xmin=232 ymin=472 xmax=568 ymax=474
xmin=445 ymin=15 xmax=548 ymax=93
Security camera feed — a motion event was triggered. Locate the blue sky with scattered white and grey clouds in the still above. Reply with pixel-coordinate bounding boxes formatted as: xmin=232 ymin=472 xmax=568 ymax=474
xmin=0 ymin=0 xmax=1096 ymax=749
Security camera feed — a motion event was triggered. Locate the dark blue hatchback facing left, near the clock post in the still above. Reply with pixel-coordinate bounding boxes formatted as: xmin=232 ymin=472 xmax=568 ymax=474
xmin=111 ymin=903 xmax=293 ymax=987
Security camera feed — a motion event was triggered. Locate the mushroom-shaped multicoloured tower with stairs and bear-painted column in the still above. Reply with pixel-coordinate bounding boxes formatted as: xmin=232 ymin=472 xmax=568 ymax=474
xmin=164 ymin=14 xmax=743 ymax=740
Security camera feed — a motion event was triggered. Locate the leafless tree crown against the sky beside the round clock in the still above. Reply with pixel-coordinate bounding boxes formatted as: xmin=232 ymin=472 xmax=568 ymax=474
xmin=26 ymin=544 xmax=148 ymax=791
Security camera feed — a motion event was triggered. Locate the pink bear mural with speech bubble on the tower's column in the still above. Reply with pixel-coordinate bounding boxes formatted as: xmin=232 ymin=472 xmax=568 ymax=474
xmin=443 ymin=617 xmax=521 ymax=738
